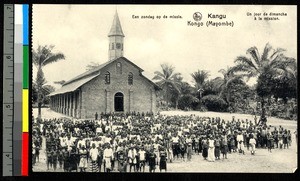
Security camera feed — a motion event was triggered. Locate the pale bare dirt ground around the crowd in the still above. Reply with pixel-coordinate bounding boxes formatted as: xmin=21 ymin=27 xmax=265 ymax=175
xmin=33 ymin=109 xmax=298 ymax=173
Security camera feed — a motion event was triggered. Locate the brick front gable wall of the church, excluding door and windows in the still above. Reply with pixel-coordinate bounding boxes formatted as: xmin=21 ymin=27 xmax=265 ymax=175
xmin=81 ymin=58 xmax=156 ymax=118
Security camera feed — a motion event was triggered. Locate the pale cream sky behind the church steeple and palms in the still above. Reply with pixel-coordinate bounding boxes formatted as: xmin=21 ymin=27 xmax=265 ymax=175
xmin=32 ymin=4 xmax=297 ymax=88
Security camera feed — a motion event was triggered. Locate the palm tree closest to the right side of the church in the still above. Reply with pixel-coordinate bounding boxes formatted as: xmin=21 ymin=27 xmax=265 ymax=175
xmin=153 ymin=64 xmax=182 ymax=109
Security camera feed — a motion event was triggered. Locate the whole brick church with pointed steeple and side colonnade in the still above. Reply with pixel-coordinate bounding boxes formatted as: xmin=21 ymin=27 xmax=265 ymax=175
xmin=49 ymin=12 xmax=159 ymax=119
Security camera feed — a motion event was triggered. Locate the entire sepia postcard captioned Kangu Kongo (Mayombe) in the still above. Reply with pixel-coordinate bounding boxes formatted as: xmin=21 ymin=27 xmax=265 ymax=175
xmin=30 ymin=4 xmax=298 ymax=174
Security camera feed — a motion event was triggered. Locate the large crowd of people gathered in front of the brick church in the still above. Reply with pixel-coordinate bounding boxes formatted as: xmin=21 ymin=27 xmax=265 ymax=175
xmin=32 ymin=113 xmax=292 ymax=172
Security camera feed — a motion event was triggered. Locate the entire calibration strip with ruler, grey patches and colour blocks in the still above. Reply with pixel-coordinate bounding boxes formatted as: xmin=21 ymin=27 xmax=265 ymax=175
xmin=2 ymin=4 xmax=29 ymax=176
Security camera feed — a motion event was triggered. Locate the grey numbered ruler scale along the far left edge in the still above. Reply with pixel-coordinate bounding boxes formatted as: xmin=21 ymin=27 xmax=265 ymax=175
xmin=2 ymin=4 xmax=14 ymax=176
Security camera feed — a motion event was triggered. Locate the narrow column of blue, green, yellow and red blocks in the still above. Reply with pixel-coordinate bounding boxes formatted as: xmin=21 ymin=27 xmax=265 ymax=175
xmin=22 ymin=4 xmax=29 ymax=176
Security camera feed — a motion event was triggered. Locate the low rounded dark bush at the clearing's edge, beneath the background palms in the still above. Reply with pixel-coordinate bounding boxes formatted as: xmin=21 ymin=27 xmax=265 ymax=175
xmin=201 ymin=95 xmax=228 ymax=112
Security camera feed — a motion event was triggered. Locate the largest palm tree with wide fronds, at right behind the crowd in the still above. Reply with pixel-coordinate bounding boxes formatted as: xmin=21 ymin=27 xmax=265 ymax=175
xmin=232 ymin=43 xmax=296 ymax=123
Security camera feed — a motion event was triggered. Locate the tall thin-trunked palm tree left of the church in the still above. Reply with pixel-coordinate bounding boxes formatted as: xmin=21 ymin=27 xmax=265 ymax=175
xmin=32 ymin=45 xmax=65 ymax=119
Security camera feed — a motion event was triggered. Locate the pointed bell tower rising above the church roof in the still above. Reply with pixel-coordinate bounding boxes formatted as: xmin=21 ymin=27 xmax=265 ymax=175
xmin=108 ymin=11 xmax=125 ymax=60
